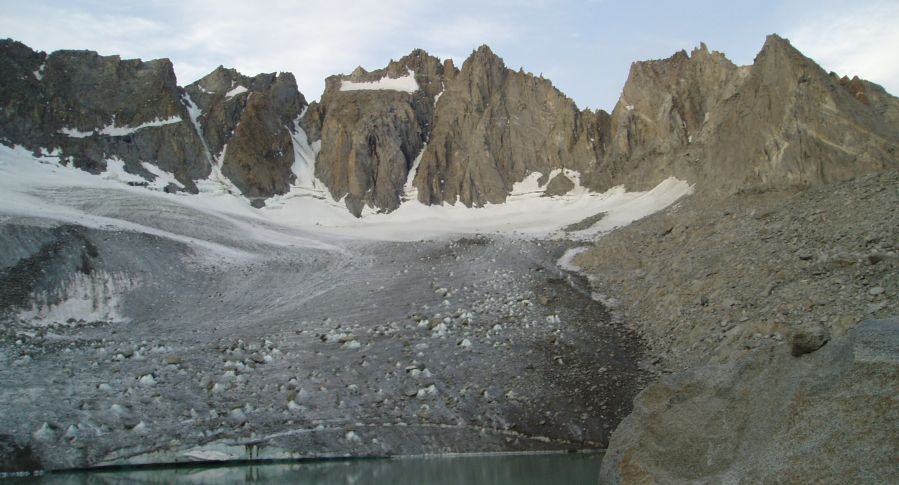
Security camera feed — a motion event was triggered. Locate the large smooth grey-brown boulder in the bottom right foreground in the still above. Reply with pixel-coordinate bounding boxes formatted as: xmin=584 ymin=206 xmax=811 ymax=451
xmin=601 ymin=318 xmax=899 ymax=484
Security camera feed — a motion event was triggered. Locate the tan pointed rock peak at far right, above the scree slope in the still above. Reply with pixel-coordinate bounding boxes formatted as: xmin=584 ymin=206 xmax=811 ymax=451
xmin=704 ymin=35 xmax=899 ymax=190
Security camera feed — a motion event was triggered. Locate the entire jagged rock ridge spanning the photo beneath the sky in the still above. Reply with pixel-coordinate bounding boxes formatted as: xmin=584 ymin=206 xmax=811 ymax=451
xmin=0 ymin=36 xmax=899 ymax=216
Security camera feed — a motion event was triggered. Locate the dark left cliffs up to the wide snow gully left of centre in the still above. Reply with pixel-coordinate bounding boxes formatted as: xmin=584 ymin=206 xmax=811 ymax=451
xmin=0 ymin=40 xmax=306 ymax=201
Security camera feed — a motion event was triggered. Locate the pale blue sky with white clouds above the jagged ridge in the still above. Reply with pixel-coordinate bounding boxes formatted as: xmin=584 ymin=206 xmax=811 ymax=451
xmin=0 ymin=0 xmax=899 ymax=111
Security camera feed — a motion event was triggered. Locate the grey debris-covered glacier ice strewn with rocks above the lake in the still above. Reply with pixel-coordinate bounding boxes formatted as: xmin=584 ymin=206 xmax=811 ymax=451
xmin=0 ymin=185 xmax=648 ymax=469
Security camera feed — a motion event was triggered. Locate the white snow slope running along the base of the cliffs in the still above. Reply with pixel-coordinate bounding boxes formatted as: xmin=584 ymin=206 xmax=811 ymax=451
xmin=0 ymin=143 xmax=692 ymax=242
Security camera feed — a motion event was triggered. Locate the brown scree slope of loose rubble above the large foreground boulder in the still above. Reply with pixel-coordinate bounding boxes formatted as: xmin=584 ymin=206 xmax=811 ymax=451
xmin=574 ymin=170 xmax=899 ymax=371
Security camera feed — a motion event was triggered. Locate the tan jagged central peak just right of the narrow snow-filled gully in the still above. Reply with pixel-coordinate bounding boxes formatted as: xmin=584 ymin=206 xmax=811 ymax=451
xmin=414 ymin=46 xmax=608 ymax=206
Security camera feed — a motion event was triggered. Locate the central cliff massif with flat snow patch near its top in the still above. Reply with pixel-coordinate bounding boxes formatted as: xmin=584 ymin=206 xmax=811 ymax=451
xmin=304 ymin=46 xmax=610 ymax=215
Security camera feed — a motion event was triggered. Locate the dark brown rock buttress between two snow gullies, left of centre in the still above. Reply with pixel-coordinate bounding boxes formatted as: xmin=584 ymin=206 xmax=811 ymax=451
xmin=186 ymin=67 xmax=306 ymax=202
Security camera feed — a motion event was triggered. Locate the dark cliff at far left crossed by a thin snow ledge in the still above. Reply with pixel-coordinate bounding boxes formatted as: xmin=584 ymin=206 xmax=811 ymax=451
xmin=0 ymin=40 xmax=210 ymax=191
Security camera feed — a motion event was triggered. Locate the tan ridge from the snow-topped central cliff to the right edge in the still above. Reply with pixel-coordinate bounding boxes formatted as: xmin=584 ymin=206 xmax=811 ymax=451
xmin=306 ymin=36 xmax=899 ymax=215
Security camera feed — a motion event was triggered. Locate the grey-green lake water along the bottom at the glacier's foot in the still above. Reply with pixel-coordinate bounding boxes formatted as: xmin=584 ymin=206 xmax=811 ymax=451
xmin=7 ymin=453 xmax=602 ymax=485
